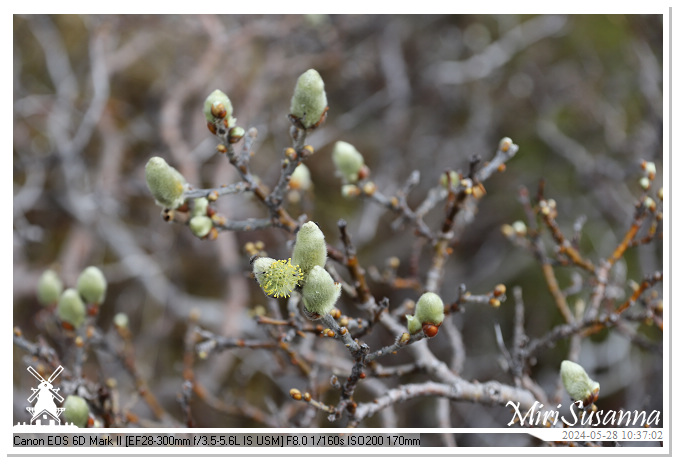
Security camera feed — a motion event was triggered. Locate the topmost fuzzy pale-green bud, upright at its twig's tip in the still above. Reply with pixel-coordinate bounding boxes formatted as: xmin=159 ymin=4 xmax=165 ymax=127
xmin=290 ymin=69 xmax=328 ymax=129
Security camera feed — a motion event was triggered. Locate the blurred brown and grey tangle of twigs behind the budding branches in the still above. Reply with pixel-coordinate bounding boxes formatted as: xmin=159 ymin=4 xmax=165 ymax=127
xmin=13 ymin=15 xmax=663 ymax=436
